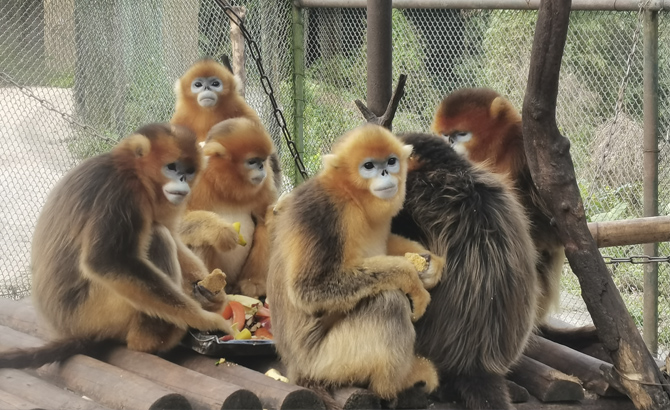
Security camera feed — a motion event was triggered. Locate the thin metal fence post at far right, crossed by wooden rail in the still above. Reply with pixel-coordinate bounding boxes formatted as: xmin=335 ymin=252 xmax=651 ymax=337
xmin=643 ymin=10 xmax=658 ymax=356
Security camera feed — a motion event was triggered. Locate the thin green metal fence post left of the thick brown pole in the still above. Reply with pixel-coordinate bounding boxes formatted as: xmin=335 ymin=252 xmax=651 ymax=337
xmin=292 ymin=4 xmax=305 ymax=185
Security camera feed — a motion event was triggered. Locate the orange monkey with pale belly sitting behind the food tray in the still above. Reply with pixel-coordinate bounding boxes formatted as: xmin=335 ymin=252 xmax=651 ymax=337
xmin=181 ymin=117 xmax=277 ymax=297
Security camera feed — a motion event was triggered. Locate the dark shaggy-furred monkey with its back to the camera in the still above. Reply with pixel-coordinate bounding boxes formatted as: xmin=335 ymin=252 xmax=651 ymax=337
xmin=392 ymin=134 xmax=538 ymax=409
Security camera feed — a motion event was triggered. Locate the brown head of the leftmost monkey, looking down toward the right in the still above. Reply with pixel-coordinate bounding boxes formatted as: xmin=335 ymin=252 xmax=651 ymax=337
xmin=112 ymin=124 xmax=202 ymax=207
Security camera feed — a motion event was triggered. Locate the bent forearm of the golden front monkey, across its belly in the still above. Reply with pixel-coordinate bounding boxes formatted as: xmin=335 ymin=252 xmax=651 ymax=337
xmin=288 ymin=255 xmax=430 ymax=319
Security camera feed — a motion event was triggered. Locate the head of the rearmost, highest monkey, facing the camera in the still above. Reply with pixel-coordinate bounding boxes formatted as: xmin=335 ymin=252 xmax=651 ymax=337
xmin=175 ymin=59 xmax=237 ymax=111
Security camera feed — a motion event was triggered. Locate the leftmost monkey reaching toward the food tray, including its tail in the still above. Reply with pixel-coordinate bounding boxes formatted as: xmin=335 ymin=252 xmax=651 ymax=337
xmin=0 ymin=124 xmax=232 ymax=368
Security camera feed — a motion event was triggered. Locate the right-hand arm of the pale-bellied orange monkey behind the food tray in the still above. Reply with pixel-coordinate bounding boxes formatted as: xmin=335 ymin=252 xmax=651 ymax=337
xmin=238 ymin=220 xmax=270 ymax=297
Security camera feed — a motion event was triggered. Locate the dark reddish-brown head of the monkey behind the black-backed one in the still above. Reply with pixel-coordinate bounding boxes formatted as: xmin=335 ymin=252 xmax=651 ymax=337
xmin=431 ymin=88 xmax=523 ymax=171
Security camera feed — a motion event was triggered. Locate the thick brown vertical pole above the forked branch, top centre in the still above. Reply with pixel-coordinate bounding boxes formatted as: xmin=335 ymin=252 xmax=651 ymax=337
xmin=366 ymin=0 xmax=393 ymax=117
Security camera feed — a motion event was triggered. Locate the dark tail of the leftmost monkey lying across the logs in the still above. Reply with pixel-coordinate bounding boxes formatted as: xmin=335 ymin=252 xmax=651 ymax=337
xmin=0 ymin=338 xmax=113 ymax=369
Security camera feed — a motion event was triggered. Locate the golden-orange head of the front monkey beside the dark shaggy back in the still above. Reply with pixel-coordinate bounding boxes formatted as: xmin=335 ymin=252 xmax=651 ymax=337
xmin=320 ymin=124 xmax=412 ymax=215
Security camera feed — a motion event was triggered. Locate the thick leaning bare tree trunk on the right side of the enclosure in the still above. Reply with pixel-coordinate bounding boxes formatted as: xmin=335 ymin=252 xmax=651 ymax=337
xmin=522 ymin=0 xmax=670 ymax=410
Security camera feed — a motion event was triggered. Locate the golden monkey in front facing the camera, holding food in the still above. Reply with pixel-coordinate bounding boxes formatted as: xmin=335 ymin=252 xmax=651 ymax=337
xmin=268 ymin=125 xmax=444 ymax=406
